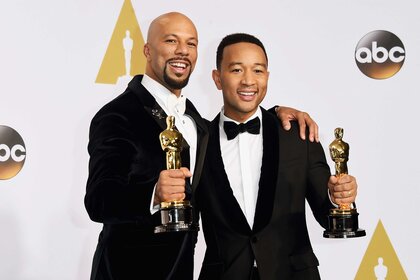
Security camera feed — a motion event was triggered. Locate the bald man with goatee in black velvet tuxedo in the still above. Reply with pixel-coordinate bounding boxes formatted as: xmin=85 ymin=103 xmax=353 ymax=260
xmin=85 ymin=12 xmax=317 ymax=280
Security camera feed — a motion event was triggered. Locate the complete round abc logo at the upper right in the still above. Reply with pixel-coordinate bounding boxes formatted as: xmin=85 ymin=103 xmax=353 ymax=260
xmin=355 ymin=30 xmax=405 ymax=79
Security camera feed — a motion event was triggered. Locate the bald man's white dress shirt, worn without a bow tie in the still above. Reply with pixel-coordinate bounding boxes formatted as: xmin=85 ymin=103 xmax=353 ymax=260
xmin=141 ymin=75 xmax=197 ymax=214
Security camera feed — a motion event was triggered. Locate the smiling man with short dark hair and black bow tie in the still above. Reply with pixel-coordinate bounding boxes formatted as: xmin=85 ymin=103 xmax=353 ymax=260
xmin=196 ymin=33 xmax=357 ymax=280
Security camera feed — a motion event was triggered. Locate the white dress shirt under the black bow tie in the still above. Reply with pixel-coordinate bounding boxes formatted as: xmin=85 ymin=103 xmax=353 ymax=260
xmin=219 ymin=108 xmax=263 ymax=229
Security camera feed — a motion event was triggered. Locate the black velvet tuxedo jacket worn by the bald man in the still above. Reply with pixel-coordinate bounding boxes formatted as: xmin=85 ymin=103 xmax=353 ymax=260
xmin=85 ymin=76 xmax=208 ymax=280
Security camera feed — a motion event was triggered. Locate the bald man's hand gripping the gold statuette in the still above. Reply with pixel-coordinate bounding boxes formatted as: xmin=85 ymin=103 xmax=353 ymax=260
xmin=154 ymin=167 xmax=192 ymax=205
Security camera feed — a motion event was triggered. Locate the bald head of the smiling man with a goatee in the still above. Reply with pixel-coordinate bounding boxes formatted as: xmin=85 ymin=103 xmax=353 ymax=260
xmin=144 ymin=12 xmax=198 ymax=95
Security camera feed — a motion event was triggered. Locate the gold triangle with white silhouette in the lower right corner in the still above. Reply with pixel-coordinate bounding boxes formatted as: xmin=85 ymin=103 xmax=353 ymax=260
xmin=354 ymin=220 xmax=408 ymax=280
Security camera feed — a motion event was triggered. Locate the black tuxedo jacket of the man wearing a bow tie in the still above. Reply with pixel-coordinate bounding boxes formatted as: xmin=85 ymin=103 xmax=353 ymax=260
xmin=196 ymin=109 xmax=333 ymax=280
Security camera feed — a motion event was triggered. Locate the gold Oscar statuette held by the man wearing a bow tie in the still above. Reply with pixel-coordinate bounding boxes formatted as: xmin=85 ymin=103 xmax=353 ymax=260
xmin=324 ymin=127 xmax=366 ymax=238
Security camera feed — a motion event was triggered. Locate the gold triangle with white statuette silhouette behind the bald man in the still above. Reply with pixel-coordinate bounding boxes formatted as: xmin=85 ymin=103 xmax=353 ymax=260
xmin=95 ymin=0 xmax=146 ymax=84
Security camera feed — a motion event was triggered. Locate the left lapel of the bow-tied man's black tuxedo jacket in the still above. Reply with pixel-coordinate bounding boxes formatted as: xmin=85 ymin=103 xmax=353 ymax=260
xmin=206 ymin=115 xmax=251 ymax=235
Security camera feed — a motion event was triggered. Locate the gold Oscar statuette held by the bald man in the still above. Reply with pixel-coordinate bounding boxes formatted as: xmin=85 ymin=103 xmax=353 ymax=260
xmin=155 ymin=116 xmax=198 ymax=233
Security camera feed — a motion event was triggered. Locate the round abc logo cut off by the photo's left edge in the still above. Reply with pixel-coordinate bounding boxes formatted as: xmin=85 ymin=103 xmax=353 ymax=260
xmin=0 ymin=125 xmax=26 ymax=180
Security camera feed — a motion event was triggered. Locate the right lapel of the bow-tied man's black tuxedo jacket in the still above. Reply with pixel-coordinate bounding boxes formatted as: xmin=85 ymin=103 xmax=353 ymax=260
xmin=253 ymin=109 xmax=279 ymax=232
